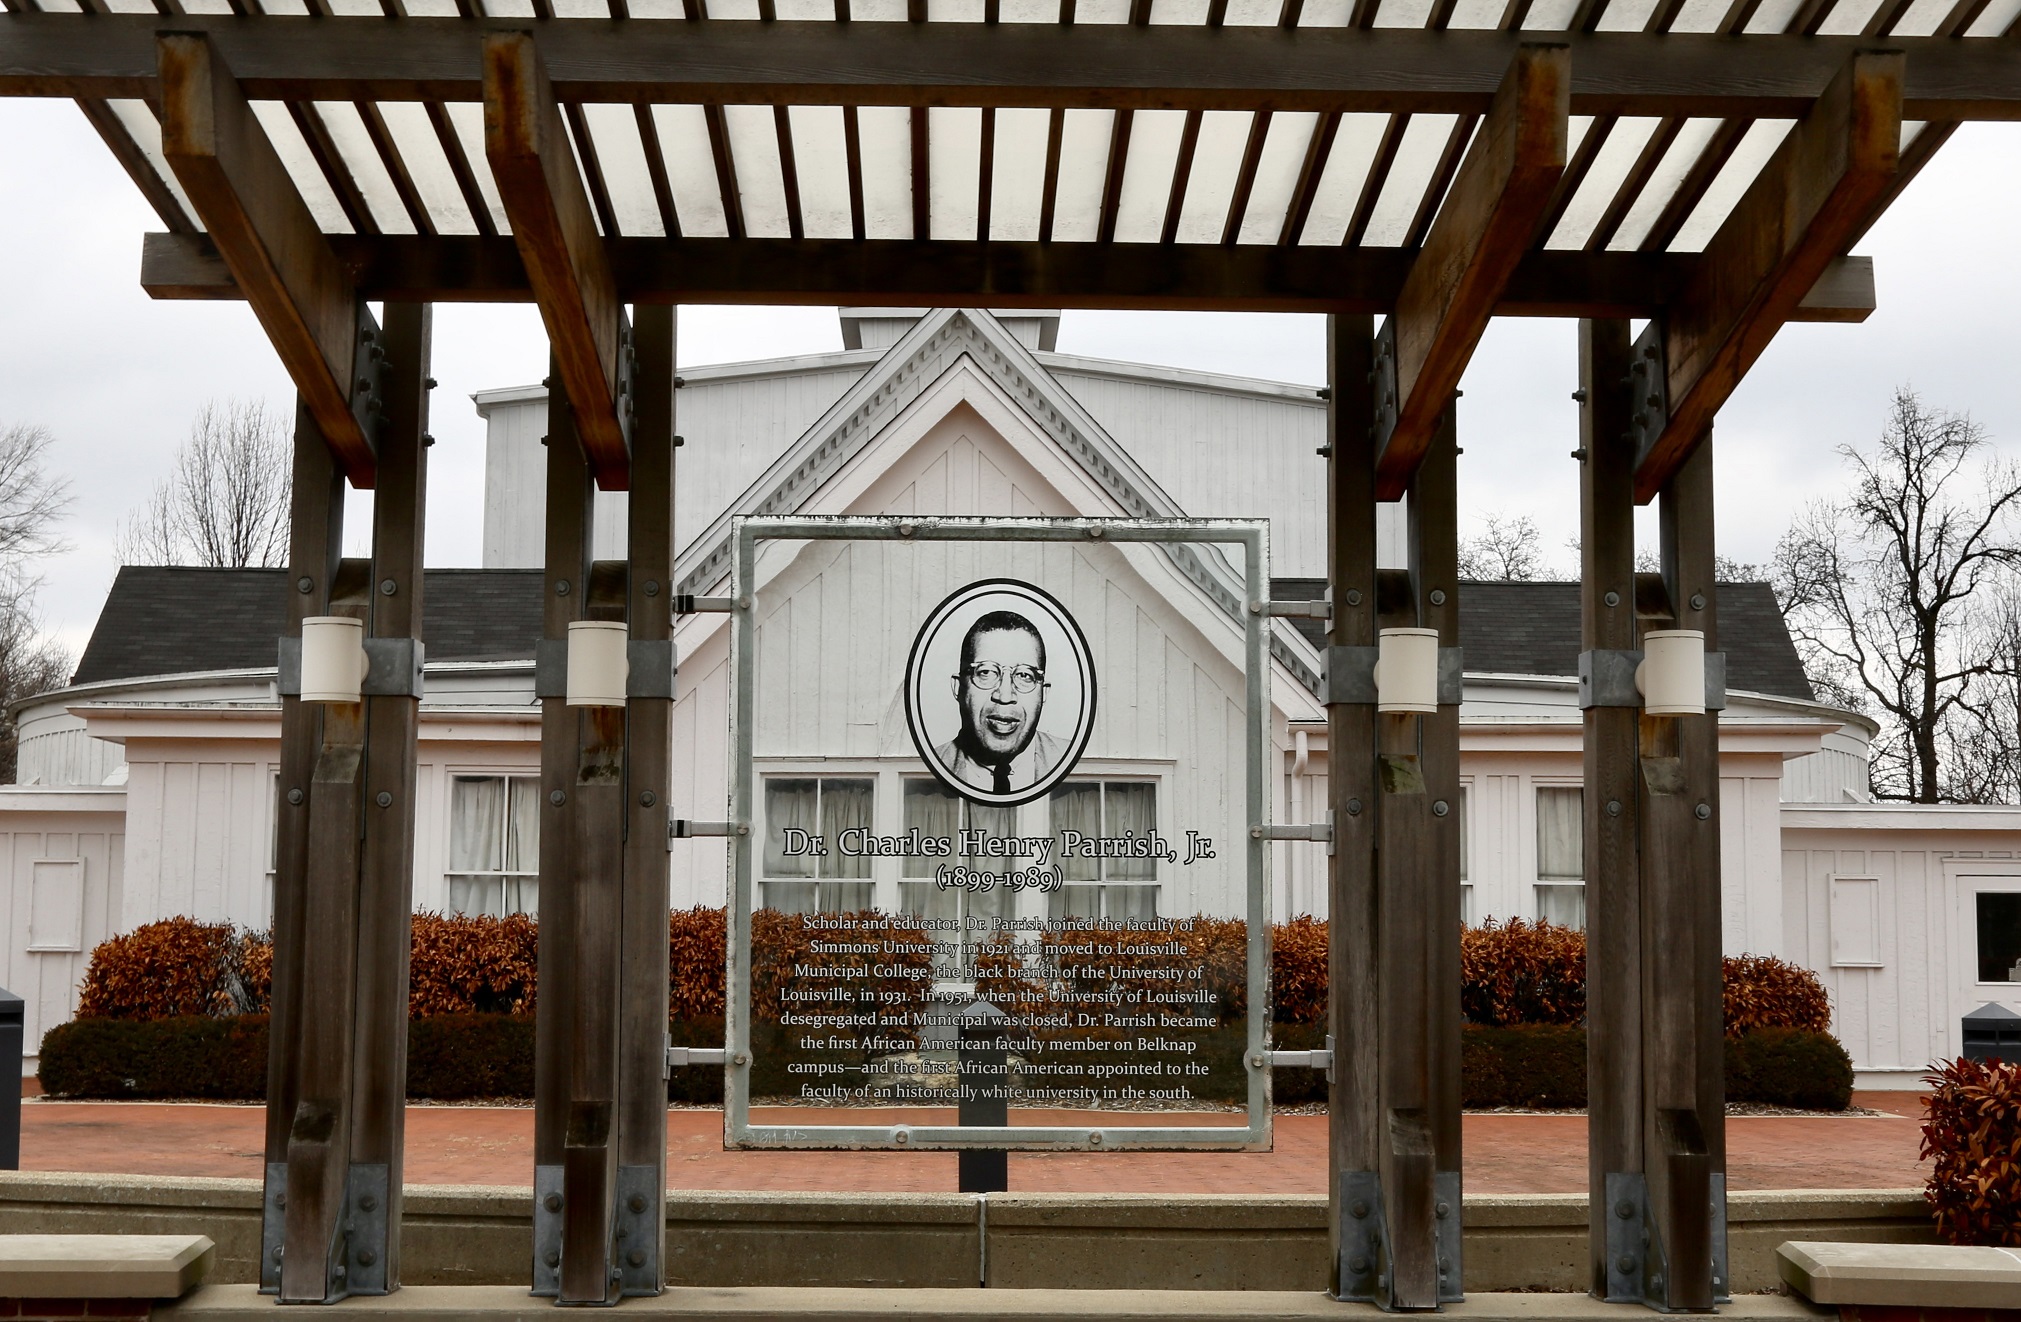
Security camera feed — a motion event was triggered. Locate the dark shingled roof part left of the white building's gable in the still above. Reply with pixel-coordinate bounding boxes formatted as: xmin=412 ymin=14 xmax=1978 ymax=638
xmin=71 ymin=564 xmax=540 ymax=683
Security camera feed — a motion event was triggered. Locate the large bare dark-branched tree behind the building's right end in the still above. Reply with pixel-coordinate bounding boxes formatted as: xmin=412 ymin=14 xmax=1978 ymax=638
xmin=1774 ymin=388 xmax=2021 ymax=802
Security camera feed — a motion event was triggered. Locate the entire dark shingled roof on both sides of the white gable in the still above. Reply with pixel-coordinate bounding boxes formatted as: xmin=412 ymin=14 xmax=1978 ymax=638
xmin=71 ymin=566 xmax=1811 ymax=697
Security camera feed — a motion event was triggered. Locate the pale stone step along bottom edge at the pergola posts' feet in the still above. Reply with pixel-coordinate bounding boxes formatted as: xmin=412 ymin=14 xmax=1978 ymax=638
xmin=154 ymin=1286 xmax=1835 ymax=1322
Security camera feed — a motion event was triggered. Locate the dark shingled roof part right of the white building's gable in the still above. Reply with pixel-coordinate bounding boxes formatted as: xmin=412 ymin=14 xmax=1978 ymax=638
xmin=1271 ymin=578 xmax=1813 ymax=701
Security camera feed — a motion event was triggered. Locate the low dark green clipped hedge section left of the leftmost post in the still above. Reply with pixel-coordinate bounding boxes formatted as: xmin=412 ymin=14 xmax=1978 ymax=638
xmin=36 ymin=1015 xmax=267 ymax=1100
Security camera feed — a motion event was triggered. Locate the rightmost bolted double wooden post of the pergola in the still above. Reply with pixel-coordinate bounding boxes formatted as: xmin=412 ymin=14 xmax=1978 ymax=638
xmin=1580 ymin=321 xmax=1728 ymax=1310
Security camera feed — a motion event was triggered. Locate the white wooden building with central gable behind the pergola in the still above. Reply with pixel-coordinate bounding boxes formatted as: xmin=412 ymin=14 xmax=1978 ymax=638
xmin=0 ymin=309 xmax=1996 ymax=1085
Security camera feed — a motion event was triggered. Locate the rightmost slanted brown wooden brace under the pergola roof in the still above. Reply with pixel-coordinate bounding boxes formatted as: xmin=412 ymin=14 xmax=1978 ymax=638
xmin=1635 ymin=51 xmax=1904 ymax=501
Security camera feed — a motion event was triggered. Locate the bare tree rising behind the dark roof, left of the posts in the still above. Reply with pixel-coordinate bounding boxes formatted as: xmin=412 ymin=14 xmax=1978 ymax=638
xmin=113 ymin=400 xmax=293 ymax=568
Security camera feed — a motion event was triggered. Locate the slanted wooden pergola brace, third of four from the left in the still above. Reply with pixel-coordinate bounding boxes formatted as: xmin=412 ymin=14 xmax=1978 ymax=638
xmin=1376 ymin=44 xmax=1570 ymax=499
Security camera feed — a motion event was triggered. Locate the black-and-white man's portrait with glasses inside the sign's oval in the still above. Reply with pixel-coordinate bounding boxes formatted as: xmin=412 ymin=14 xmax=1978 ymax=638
xmin=934 ymin=610 xmax=1061 ymax=794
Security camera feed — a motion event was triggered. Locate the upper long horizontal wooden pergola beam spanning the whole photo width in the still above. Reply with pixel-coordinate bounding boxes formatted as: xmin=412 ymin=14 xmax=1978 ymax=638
xmin=0 ymin=12 xmax=2021 ymax=121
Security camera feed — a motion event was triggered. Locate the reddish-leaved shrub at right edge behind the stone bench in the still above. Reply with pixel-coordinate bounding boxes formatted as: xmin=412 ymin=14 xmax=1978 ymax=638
xmin=1922 ymin=1059 xmax=2021 ymax=1249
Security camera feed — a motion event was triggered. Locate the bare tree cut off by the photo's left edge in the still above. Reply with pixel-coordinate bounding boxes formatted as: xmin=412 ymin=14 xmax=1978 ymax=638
xmin=0 ymin=422 xmax=71 ymax=784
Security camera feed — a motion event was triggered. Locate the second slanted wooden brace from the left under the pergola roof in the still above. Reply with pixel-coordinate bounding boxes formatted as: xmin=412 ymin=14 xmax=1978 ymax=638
xmin=483 ymin=32 xmax=631 ymax=491
